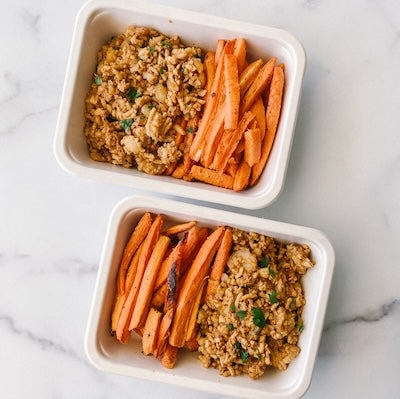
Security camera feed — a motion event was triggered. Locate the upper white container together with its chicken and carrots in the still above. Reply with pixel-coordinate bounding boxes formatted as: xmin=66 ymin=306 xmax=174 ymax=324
xmin=55 ymin=1 xmax=305 ymax=208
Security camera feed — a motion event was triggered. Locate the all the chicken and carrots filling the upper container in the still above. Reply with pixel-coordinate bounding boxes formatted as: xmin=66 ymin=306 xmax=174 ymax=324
xmin=85 ymin=26 xmax=285 ymax=191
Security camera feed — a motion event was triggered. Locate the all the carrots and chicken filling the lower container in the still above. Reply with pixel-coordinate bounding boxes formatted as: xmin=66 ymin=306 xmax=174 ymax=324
xmin=111 ymin=212 xmax=313 ymax=379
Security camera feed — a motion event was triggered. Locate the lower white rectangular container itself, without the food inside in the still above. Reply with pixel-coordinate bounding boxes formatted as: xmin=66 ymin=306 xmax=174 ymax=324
xmin=85 ymin=197 xmax=334 ymax=399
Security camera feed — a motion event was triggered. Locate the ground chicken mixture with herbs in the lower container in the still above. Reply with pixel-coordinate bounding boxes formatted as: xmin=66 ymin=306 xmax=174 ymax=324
xmin=198 ymin=230 xmax=313 ymax=379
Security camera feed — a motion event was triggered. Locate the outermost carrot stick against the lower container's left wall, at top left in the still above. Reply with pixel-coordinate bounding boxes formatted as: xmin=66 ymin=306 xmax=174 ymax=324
xmin=117 ymin=212 xmax=152 ymax=294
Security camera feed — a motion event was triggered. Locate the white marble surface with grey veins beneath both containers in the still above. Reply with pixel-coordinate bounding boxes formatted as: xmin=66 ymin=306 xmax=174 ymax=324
xmin=0 ymin=0 xmax=400 ymax=399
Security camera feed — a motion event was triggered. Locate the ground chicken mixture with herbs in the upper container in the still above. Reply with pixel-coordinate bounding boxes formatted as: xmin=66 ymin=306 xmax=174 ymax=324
xmin=85 ymin=26 xmax=205 ymax=174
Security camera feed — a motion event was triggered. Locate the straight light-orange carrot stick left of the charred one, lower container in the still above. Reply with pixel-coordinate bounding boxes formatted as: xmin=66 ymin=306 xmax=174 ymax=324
xmin=129 ymin=235 xmax=171 ymax=330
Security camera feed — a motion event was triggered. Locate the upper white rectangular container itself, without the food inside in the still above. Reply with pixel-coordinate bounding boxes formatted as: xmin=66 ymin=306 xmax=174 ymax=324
xmin=54 ymin=0 xmax=305 ymax=209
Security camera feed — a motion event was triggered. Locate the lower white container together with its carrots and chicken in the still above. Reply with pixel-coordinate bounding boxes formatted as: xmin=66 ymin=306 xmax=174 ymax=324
xmin=86 ymin=197 xmax=334 ymax=397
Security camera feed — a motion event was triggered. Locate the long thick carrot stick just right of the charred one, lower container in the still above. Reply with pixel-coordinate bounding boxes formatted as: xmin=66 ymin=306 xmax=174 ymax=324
xmin=169 ymin=227 xmax=225 ymax=348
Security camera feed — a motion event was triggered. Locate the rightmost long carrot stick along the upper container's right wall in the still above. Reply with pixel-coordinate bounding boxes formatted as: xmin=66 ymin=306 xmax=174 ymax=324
xmin=250 ymin=67 xmax=285 ymax=186
